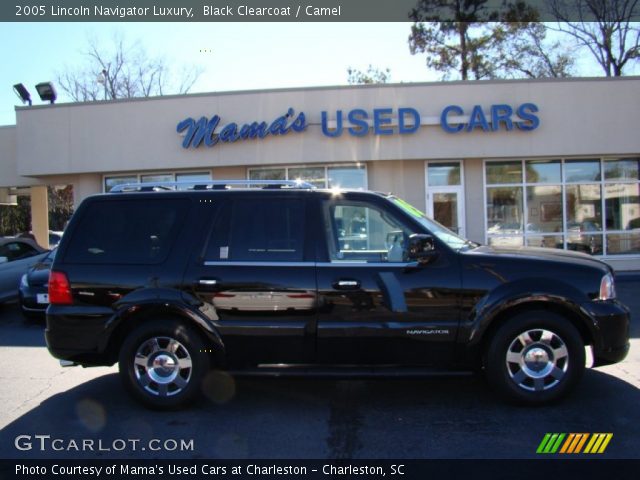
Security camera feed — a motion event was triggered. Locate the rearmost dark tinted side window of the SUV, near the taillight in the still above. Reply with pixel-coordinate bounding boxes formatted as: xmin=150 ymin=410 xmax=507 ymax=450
xmin=65 ymin=199 xmax=189 ymax=265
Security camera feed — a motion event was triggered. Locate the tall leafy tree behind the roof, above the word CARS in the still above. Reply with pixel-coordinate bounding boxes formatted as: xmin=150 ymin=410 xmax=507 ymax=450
xmin=409 ymin=0 xmax=571 ymax=80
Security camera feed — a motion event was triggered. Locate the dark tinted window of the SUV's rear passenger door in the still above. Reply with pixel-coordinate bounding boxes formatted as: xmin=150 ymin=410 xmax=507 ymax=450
xmin=207 ymin=198 xmax=305 ymax=262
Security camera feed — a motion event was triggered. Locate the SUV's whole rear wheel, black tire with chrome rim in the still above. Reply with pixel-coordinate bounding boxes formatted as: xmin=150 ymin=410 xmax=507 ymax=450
xmin=118 ymin=318 xmax=209 ymax=410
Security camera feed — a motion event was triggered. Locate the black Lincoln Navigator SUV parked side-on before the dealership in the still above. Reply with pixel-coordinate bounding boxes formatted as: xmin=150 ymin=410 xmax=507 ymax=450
xmin=46 ymin=181 xmax=629 ymax=408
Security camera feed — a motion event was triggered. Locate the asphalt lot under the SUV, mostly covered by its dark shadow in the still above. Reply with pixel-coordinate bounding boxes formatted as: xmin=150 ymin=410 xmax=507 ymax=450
xmin=0 ymin=276 xmax=640 ymax=459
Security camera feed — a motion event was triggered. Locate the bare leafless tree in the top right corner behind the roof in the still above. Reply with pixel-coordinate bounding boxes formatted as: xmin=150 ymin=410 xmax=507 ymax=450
xmin=549 ymin=0 xmax=640 ymax=77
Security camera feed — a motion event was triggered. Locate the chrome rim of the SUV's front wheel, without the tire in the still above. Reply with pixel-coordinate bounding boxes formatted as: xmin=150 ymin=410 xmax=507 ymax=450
xmin=506 ymin=328 xmax=569 ymax=392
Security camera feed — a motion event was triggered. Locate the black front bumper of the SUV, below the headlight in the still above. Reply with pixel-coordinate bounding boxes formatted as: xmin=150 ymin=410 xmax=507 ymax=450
xmin=582 ymin=300 xmax=631 ymax=367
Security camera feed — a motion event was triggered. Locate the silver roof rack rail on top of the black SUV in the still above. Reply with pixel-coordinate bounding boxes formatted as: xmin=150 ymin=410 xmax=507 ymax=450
xmin=109 ymin=180 xmax=316 ymax=193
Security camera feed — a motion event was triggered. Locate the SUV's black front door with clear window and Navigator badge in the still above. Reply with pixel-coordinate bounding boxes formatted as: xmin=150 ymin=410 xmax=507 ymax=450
xmin=317 ymin=196 xmax=460 ymax=365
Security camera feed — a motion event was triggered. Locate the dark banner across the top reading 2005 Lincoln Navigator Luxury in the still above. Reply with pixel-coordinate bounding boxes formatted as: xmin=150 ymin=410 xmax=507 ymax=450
xmin=0 ymin=0 xmax=640 ymax=22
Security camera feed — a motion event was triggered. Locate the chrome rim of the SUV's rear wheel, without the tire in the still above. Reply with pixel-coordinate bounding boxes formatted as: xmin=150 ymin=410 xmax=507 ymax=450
xmin=133 ymin=337 xmax=193 ymax=397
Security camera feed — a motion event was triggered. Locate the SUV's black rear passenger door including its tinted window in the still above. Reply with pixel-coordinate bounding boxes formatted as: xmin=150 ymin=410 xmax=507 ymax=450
xmin=187 ymin=192 xmax=317 ymax=364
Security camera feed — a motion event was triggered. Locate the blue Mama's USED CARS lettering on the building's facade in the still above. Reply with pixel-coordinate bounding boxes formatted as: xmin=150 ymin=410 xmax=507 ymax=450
xmin=176 ymin=103 xmax=540 ymax=148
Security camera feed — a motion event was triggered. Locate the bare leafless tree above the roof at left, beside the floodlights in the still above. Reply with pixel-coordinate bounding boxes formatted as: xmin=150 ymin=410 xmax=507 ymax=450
xmin=57 ymin=35 xmax=203 ymax=101
